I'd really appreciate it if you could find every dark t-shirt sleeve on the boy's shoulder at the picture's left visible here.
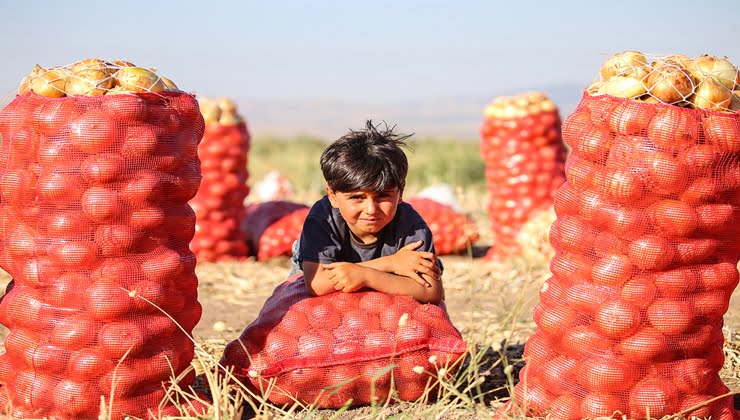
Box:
[298,217,342,264]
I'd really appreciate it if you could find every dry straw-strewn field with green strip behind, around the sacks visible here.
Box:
[2,138,740,419]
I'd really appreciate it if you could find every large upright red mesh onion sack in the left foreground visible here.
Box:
[0,59,204,419]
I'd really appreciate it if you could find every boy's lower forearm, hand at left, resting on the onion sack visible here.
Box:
[321,262,444,304]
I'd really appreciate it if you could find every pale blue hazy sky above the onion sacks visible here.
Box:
[0,0,740,102]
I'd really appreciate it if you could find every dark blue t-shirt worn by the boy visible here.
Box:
[291,196,442,275]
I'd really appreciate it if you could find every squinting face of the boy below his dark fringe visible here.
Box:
[326,187,402,244]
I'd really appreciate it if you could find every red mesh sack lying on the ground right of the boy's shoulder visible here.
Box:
[404,197,479,255]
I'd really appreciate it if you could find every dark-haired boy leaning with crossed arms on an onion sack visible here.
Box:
[291,121,444,304]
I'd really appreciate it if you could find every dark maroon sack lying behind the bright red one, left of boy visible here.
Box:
[241,200,308,253]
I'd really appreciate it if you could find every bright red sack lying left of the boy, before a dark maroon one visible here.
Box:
[247,202,311,261]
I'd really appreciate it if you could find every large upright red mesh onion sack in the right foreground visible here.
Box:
[502,51,740,419]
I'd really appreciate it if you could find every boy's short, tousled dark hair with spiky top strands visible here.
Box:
[321,120,411,192]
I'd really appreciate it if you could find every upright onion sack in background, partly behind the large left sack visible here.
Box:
[190,98,249,262]
